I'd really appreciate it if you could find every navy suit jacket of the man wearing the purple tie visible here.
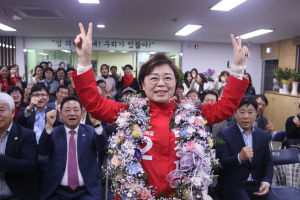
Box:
[38,124,107,200]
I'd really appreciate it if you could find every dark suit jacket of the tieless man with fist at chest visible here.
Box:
[216,124,273,199]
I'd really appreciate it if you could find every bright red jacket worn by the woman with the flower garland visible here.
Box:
[72,69,249,194]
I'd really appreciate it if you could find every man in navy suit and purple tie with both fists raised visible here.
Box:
[38,96,107,200]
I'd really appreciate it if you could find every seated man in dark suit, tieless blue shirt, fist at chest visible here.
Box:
[216,96,277,200]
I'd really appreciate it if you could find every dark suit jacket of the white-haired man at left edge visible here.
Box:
[0,123,39,200]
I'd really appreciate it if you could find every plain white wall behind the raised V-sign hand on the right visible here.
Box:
[182,42,262,94]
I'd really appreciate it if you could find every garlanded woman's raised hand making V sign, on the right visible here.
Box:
[231,33,250,66]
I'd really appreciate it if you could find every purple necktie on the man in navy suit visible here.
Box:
[68,130,79,190]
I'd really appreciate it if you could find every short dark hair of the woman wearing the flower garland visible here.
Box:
[138,54,179,96]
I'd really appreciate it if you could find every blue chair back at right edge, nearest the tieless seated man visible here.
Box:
[270,148,300,165]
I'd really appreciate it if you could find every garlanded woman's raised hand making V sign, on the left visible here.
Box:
[74,23,93,67]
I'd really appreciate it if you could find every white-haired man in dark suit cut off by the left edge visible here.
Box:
[0,93,38,200]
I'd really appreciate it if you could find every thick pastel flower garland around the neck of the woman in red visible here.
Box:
[106,94,218,200]
